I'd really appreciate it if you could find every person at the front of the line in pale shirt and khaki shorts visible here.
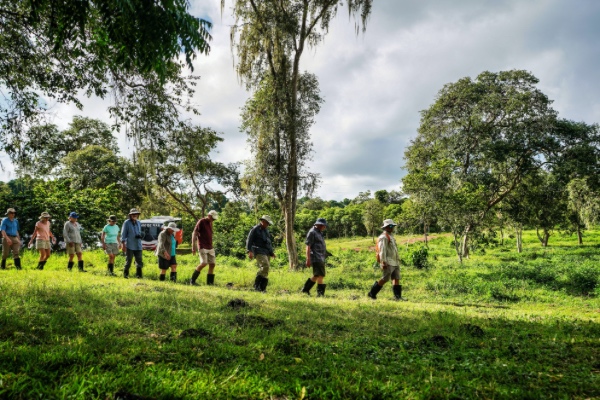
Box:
[367,219,406,301]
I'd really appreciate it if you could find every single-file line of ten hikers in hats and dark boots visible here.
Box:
[0,208,405,300]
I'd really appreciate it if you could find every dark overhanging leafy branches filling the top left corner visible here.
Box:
[0,0,211,157]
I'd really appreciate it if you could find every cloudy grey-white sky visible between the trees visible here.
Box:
[5,0,600,199]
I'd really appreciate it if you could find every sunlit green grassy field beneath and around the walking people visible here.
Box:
[0,232,600,399]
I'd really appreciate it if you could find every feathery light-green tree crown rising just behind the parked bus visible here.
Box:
[143,123,240,220]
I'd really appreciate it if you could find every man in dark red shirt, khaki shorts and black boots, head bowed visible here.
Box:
[190,210,219,286]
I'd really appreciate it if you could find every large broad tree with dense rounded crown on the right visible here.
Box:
[403,70,556,256]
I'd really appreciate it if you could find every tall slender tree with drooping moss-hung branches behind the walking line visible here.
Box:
[226,0,372,269]
